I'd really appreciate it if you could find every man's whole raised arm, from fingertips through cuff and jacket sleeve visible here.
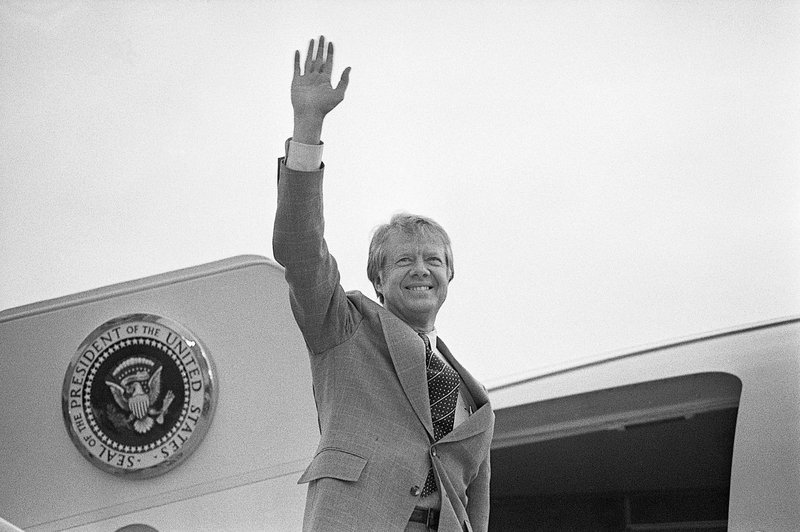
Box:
[272,37,359,354]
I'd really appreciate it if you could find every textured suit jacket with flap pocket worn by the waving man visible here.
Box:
[273,159,494,531]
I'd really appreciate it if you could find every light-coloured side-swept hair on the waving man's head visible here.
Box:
[367,212,455,303]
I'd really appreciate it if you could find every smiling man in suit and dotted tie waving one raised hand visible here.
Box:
[273,37,494,531]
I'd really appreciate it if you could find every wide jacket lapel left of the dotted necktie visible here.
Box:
[378,311,433,438]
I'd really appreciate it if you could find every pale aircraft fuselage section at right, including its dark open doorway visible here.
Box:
[489,318,800,530]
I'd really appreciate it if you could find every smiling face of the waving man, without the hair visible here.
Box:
[375,233,450,332]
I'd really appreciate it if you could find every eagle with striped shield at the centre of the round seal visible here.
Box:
[105,356,175,434]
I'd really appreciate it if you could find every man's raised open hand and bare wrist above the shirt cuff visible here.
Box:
[292,36,350,144]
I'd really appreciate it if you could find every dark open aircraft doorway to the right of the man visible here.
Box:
[490,373,741,532]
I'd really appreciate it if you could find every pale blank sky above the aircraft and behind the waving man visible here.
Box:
[0,0,800,382]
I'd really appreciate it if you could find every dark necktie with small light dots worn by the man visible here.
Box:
[419,333,461,497]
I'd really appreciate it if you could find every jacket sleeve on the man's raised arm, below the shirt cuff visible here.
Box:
[272,158,360,354]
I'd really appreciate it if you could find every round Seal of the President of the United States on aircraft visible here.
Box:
[61,314,217,478]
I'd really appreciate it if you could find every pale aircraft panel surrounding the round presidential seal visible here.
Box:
[0,256,319,531]
